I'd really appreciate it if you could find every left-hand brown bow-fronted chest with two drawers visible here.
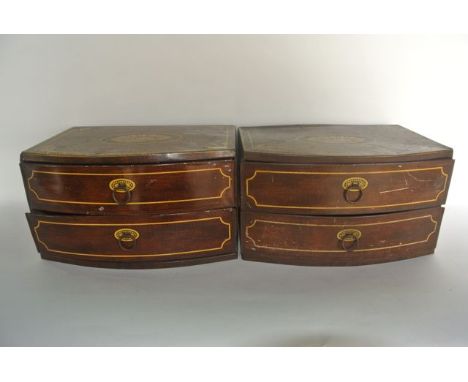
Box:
[20,126,237,268]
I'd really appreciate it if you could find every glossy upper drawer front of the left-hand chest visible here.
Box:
[22,160,235,215]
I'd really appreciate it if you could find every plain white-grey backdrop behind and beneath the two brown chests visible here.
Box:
[0,35,468,345]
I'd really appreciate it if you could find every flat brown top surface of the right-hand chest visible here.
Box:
[240,125,452,163]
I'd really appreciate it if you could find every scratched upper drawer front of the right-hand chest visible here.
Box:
[241,159,453,215]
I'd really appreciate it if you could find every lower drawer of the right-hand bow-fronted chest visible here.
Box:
[241,207,443,265]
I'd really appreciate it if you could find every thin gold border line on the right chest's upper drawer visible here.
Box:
[245,166,448,210]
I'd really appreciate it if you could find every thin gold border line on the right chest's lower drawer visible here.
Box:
[245,215,438,253]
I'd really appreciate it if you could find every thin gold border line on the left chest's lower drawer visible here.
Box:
[33,216,232,258]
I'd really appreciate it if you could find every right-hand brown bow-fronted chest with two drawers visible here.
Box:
[240,125,454,265]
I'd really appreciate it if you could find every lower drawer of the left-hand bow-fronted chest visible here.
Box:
[26,209,237,268]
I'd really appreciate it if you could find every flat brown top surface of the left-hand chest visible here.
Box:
[21,125,235,164]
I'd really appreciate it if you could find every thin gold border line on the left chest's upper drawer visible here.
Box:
[28,167,232,205]
